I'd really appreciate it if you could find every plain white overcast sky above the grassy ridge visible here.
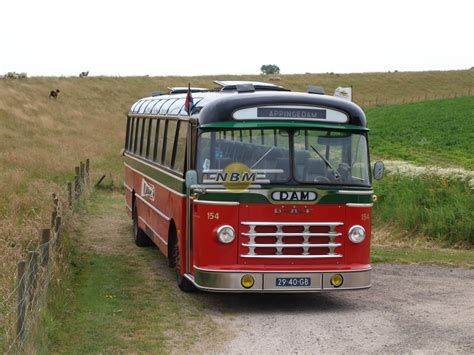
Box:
[0,0,474,76]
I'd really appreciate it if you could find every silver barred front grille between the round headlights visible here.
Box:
[240,222,344,259]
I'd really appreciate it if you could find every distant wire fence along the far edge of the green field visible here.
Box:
[354,88,474,107]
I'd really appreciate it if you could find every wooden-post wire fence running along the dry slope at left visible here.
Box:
[0,159,91,354]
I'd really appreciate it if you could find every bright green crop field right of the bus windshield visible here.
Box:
[366,96,474,170]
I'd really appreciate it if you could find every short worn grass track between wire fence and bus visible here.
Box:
[39,191,219,354]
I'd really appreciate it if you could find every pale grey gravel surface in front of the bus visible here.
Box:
[196,265,474,354]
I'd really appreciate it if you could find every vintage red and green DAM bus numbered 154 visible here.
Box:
[123,81,383,292]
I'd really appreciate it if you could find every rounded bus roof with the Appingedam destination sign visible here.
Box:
[129,83,367,127]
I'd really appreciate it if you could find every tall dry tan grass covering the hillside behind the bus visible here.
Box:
[0,70,474,318]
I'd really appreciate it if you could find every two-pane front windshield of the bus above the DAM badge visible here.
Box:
[197,129,370,186]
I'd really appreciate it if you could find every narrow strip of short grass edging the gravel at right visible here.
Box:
[372,246,474,269]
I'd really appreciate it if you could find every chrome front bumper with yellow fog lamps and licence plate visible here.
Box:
[185,266,372,293]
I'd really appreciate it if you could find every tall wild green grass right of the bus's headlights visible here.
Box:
[373,175,474,247]
